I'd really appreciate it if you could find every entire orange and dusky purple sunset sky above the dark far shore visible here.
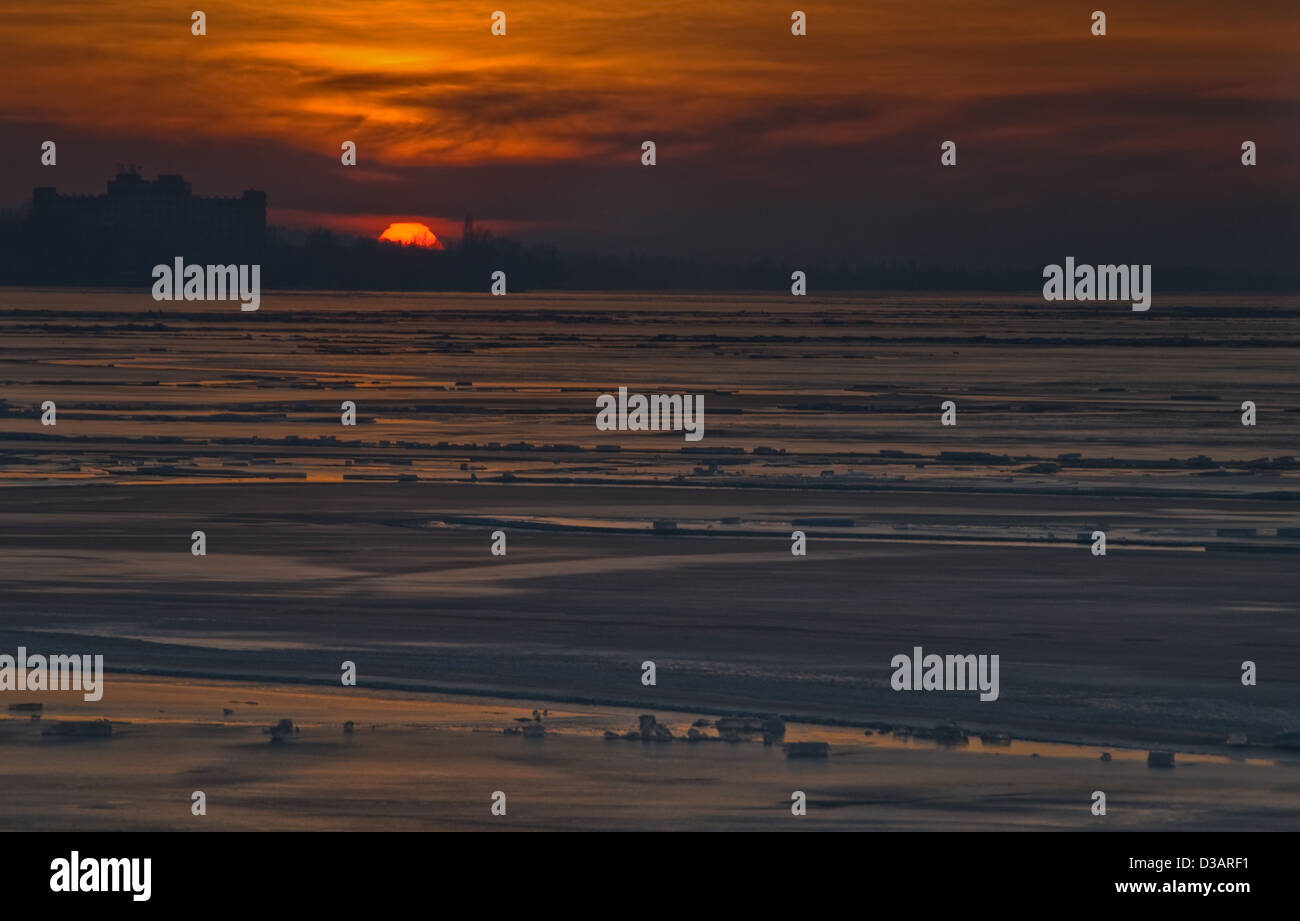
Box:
[0,0,1300,269]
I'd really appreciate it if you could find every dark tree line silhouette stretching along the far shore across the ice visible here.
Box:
[0,213,1300,294]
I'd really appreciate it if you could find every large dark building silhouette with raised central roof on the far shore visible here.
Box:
[27,168,267,284]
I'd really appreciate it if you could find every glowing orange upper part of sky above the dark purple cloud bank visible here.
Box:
[0,0,1300,163]
